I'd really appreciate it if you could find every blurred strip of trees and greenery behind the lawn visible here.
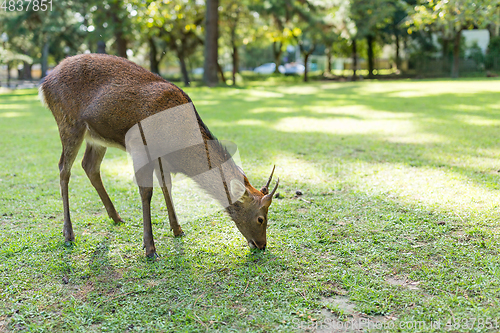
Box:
[0,0,500,88]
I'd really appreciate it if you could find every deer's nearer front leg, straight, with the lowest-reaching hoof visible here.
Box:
[136,163,158,258]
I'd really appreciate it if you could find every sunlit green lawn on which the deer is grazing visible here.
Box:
[0,78,500,332]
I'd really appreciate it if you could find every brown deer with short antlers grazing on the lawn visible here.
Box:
[39,54,279,258]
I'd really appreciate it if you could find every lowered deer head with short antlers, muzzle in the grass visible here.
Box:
[226,167,279,250]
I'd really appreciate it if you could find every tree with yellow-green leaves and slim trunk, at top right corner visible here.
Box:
[408,0,500,78]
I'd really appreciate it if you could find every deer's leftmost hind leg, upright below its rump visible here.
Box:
[59,125,85,242]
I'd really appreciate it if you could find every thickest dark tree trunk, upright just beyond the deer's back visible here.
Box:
[203,0,219,87]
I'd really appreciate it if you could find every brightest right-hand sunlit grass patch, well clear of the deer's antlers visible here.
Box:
[350,162,500,222]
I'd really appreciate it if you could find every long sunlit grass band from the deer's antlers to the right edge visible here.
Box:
[260,150,500,222]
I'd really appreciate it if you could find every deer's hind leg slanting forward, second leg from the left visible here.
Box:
[82,142,123,224]
